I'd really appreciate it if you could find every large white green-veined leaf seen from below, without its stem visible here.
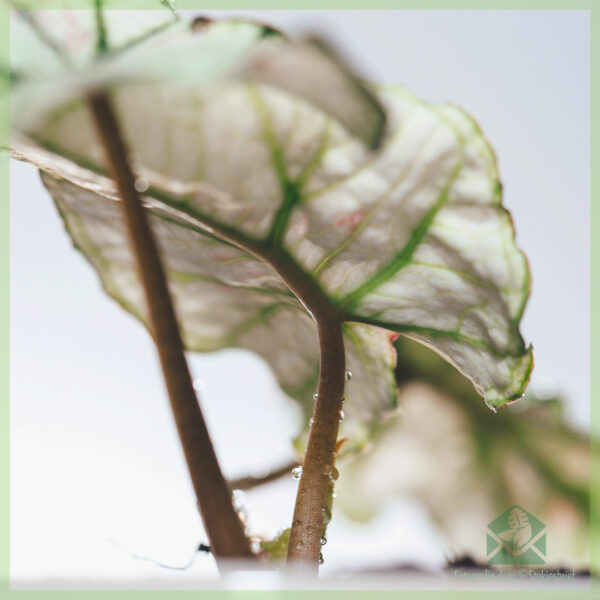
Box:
[13,12,532,436]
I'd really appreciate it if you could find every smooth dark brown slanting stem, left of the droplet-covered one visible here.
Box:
[89,93,254,559]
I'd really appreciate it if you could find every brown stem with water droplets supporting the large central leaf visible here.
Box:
[288,312,346,571]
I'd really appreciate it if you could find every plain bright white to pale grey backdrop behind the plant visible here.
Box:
[11,11,590,586]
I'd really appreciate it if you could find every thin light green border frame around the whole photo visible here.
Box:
[0,0,600,600]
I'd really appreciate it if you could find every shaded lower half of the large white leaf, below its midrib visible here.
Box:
[36,173,396,442]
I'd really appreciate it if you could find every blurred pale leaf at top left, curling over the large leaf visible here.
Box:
[11,7,385,147]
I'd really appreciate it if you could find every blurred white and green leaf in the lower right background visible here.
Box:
[337,338,600,572]
